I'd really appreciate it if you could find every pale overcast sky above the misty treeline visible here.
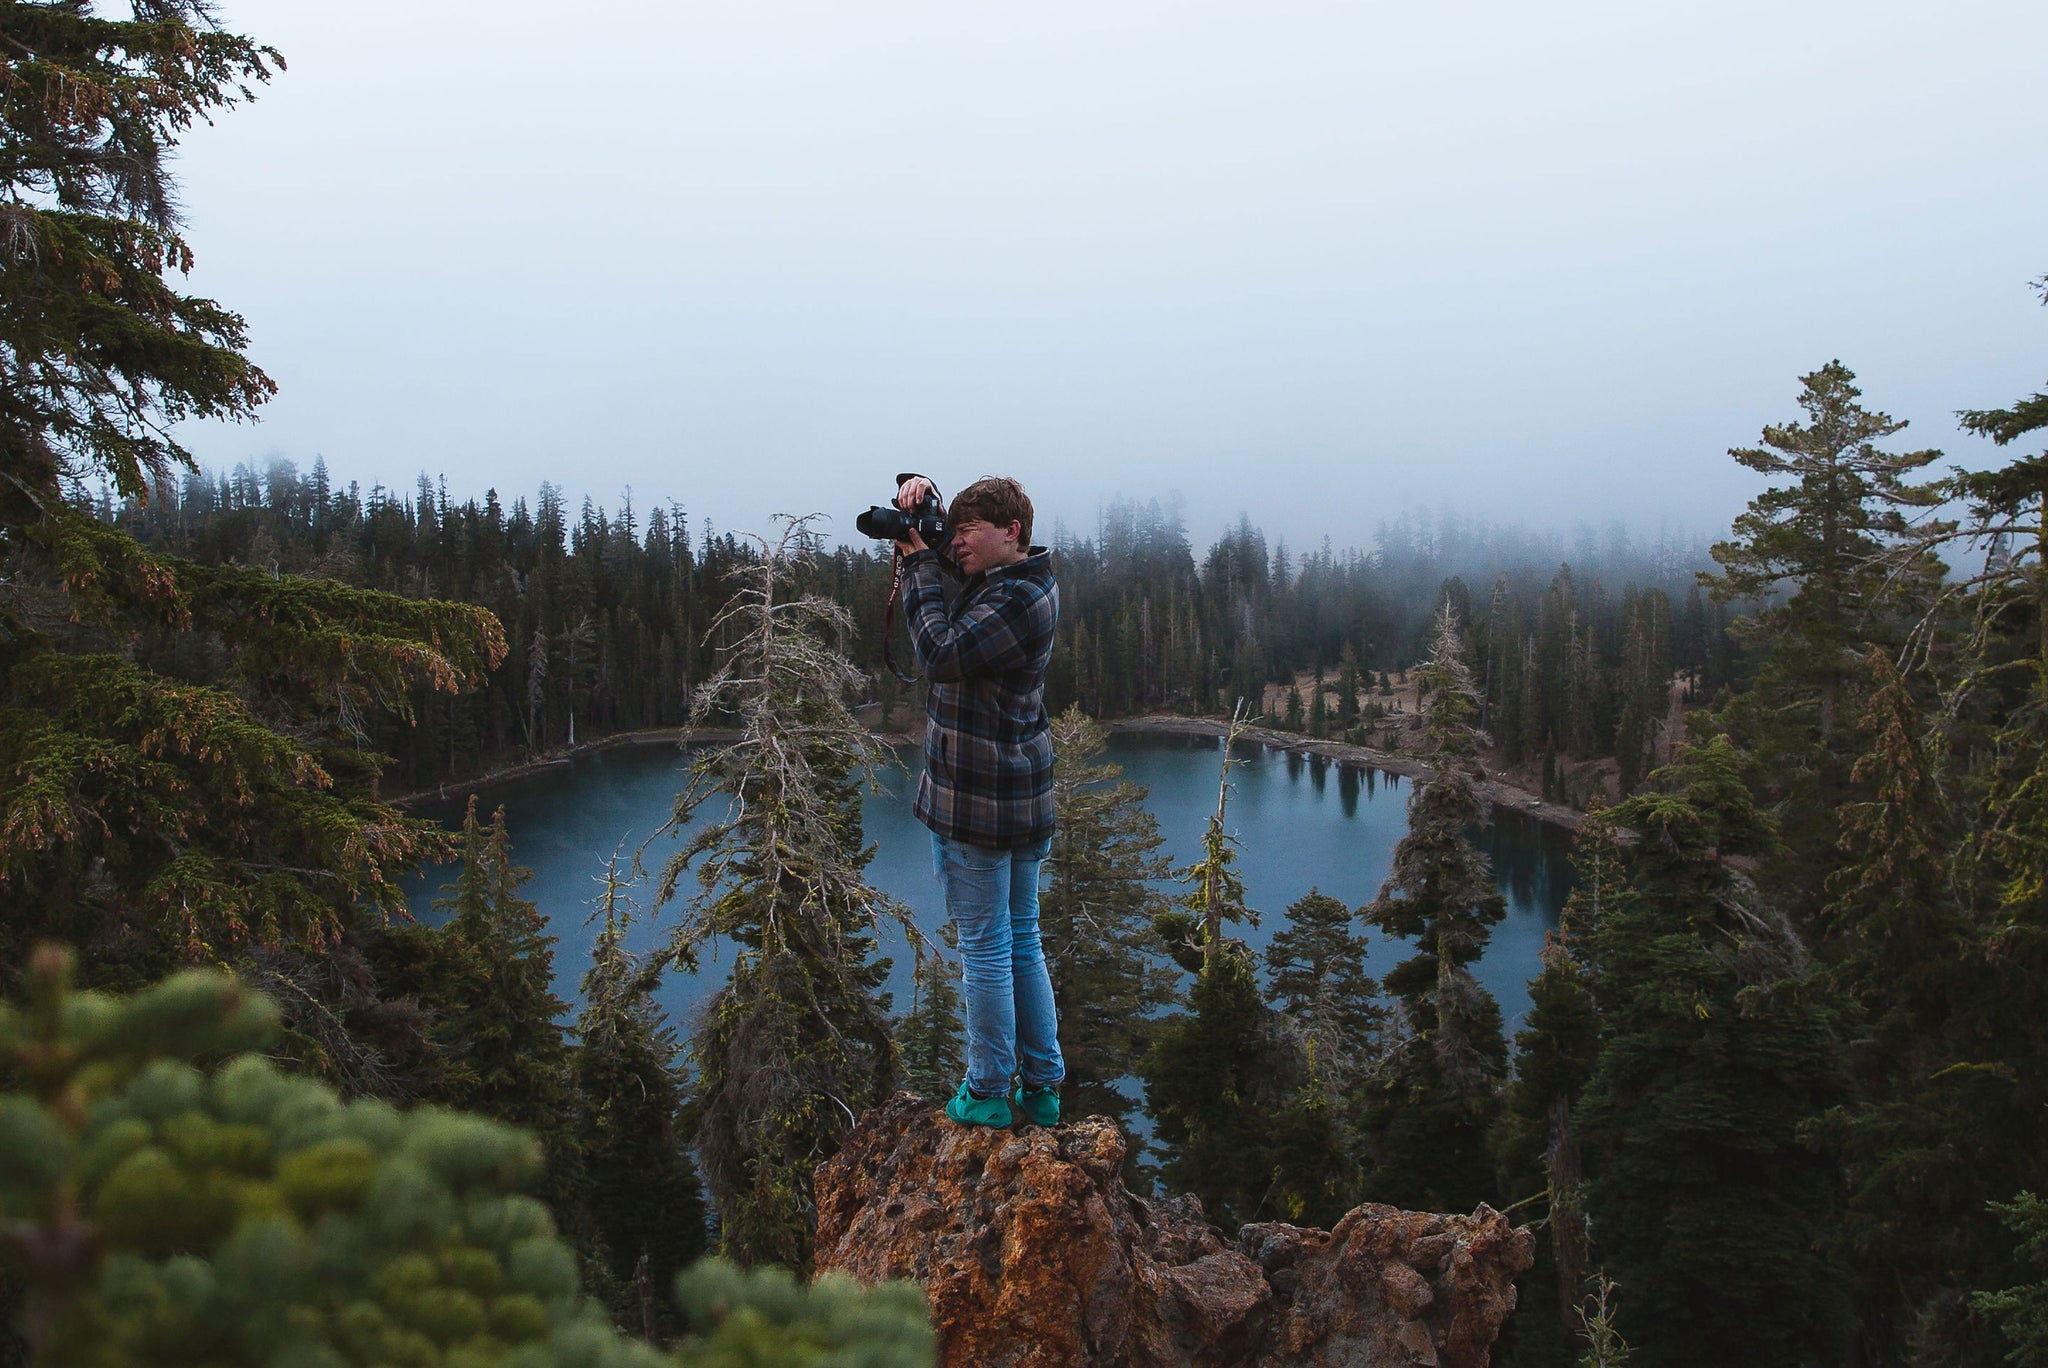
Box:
[180,0,2048,547]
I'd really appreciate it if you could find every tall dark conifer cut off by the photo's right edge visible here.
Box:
[1819,286,2048,1362]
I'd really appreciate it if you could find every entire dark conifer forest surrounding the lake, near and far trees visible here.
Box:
[0,0,2048,1368]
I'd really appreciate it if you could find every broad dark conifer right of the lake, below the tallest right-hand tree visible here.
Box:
[1573,737,1845,1368]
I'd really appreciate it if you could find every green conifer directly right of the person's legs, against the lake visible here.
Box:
[1038,707,1174,1138]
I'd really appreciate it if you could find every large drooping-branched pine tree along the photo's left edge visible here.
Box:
[0,0,504,995]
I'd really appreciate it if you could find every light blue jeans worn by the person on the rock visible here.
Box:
[932,831,1067,1098]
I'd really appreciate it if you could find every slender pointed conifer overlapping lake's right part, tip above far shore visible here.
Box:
[1360,606,1507,1210]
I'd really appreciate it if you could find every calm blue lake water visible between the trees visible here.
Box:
[408,735,1571,1036]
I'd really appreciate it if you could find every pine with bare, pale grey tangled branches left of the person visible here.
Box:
[657,518,924,1272]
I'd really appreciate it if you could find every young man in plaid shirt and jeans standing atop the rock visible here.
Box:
[897,475,1067,1126]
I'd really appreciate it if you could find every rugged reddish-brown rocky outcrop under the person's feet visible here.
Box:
[815,1096,1534,1368]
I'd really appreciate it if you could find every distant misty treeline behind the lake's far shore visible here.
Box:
[100,459,1731,786]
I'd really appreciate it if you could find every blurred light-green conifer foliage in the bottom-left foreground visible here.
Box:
[0,948,930,1368]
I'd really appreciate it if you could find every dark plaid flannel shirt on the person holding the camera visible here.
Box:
[903,547,1059,850]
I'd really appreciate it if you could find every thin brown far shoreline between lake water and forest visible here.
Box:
[387,713,1581,831]
